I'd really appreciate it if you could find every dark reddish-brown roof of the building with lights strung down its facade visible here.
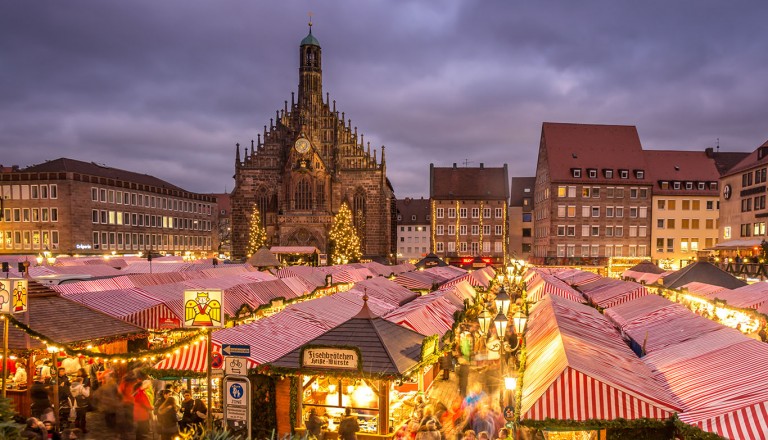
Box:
[429,164,509,200]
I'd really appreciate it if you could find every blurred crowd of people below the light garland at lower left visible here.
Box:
[22,360,208,440]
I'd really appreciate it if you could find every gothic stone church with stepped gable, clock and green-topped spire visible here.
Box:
[232,25,396,259]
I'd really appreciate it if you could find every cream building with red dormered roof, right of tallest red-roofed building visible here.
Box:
[645,149,720,270]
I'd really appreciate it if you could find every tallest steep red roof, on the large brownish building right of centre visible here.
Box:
[541,122,651,184]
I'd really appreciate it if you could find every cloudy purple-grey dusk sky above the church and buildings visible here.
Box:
[0,0,768,197]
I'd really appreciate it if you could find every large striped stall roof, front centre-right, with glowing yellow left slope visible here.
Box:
[521,295,681,421]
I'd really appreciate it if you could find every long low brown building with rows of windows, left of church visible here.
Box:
[0,158,218,255]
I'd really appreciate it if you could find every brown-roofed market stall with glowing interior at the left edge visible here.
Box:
[0,281,147,417]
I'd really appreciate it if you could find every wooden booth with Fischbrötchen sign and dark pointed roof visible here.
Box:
[262,297,439,440]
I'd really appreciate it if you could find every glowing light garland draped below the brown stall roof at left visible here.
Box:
[8,315,205,364]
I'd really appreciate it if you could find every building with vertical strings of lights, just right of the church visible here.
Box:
[429,163,510,265]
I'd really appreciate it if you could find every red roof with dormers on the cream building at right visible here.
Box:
[645,150,720,195]
